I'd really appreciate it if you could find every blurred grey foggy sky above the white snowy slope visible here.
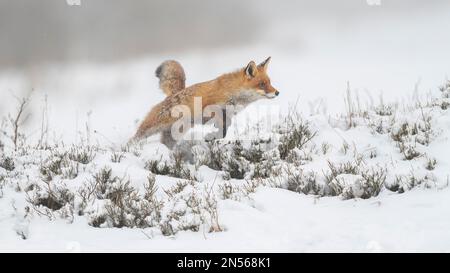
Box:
[0,0,450,68]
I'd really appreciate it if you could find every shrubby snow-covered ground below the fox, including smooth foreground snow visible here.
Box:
[0,78,450,251]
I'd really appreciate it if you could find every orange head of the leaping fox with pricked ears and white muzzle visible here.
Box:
[244,57,280,99]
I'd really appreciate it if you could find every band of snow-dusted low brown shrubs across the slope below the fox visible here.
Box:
[0,79,450,242]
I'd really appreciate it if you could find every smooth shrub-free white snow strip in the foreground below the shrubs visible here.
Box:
[0,186,450,252]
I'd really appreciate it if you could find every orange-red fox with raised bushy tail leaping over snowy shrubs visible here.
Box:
[133,57,279,149]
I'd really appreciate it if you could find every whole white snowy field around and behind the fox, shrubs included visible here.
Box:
[0,3,450,252]
